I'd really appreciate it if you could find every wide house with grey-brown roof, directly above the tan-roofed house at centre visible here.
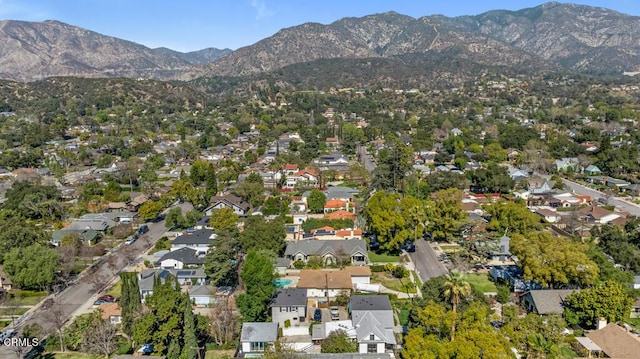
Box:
[284,239,369,265]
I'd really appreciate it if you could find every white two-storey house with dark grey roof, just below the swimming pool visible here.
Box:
[271,288,307,328]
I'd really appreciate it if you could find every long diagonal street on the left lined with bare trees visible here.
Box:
[0,203,193,358]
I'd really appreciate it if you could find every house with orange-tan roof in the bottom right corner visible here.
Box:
[576,319,640,359]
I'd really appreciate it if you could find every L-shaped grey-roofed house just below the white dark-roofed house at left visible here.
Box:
[138,268,207,302]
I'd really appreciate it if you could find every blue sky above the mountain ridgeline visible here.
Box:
[0,0,640,51]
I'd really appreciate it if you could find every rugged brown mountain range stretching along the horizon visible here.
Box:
[0,2,640,83]
